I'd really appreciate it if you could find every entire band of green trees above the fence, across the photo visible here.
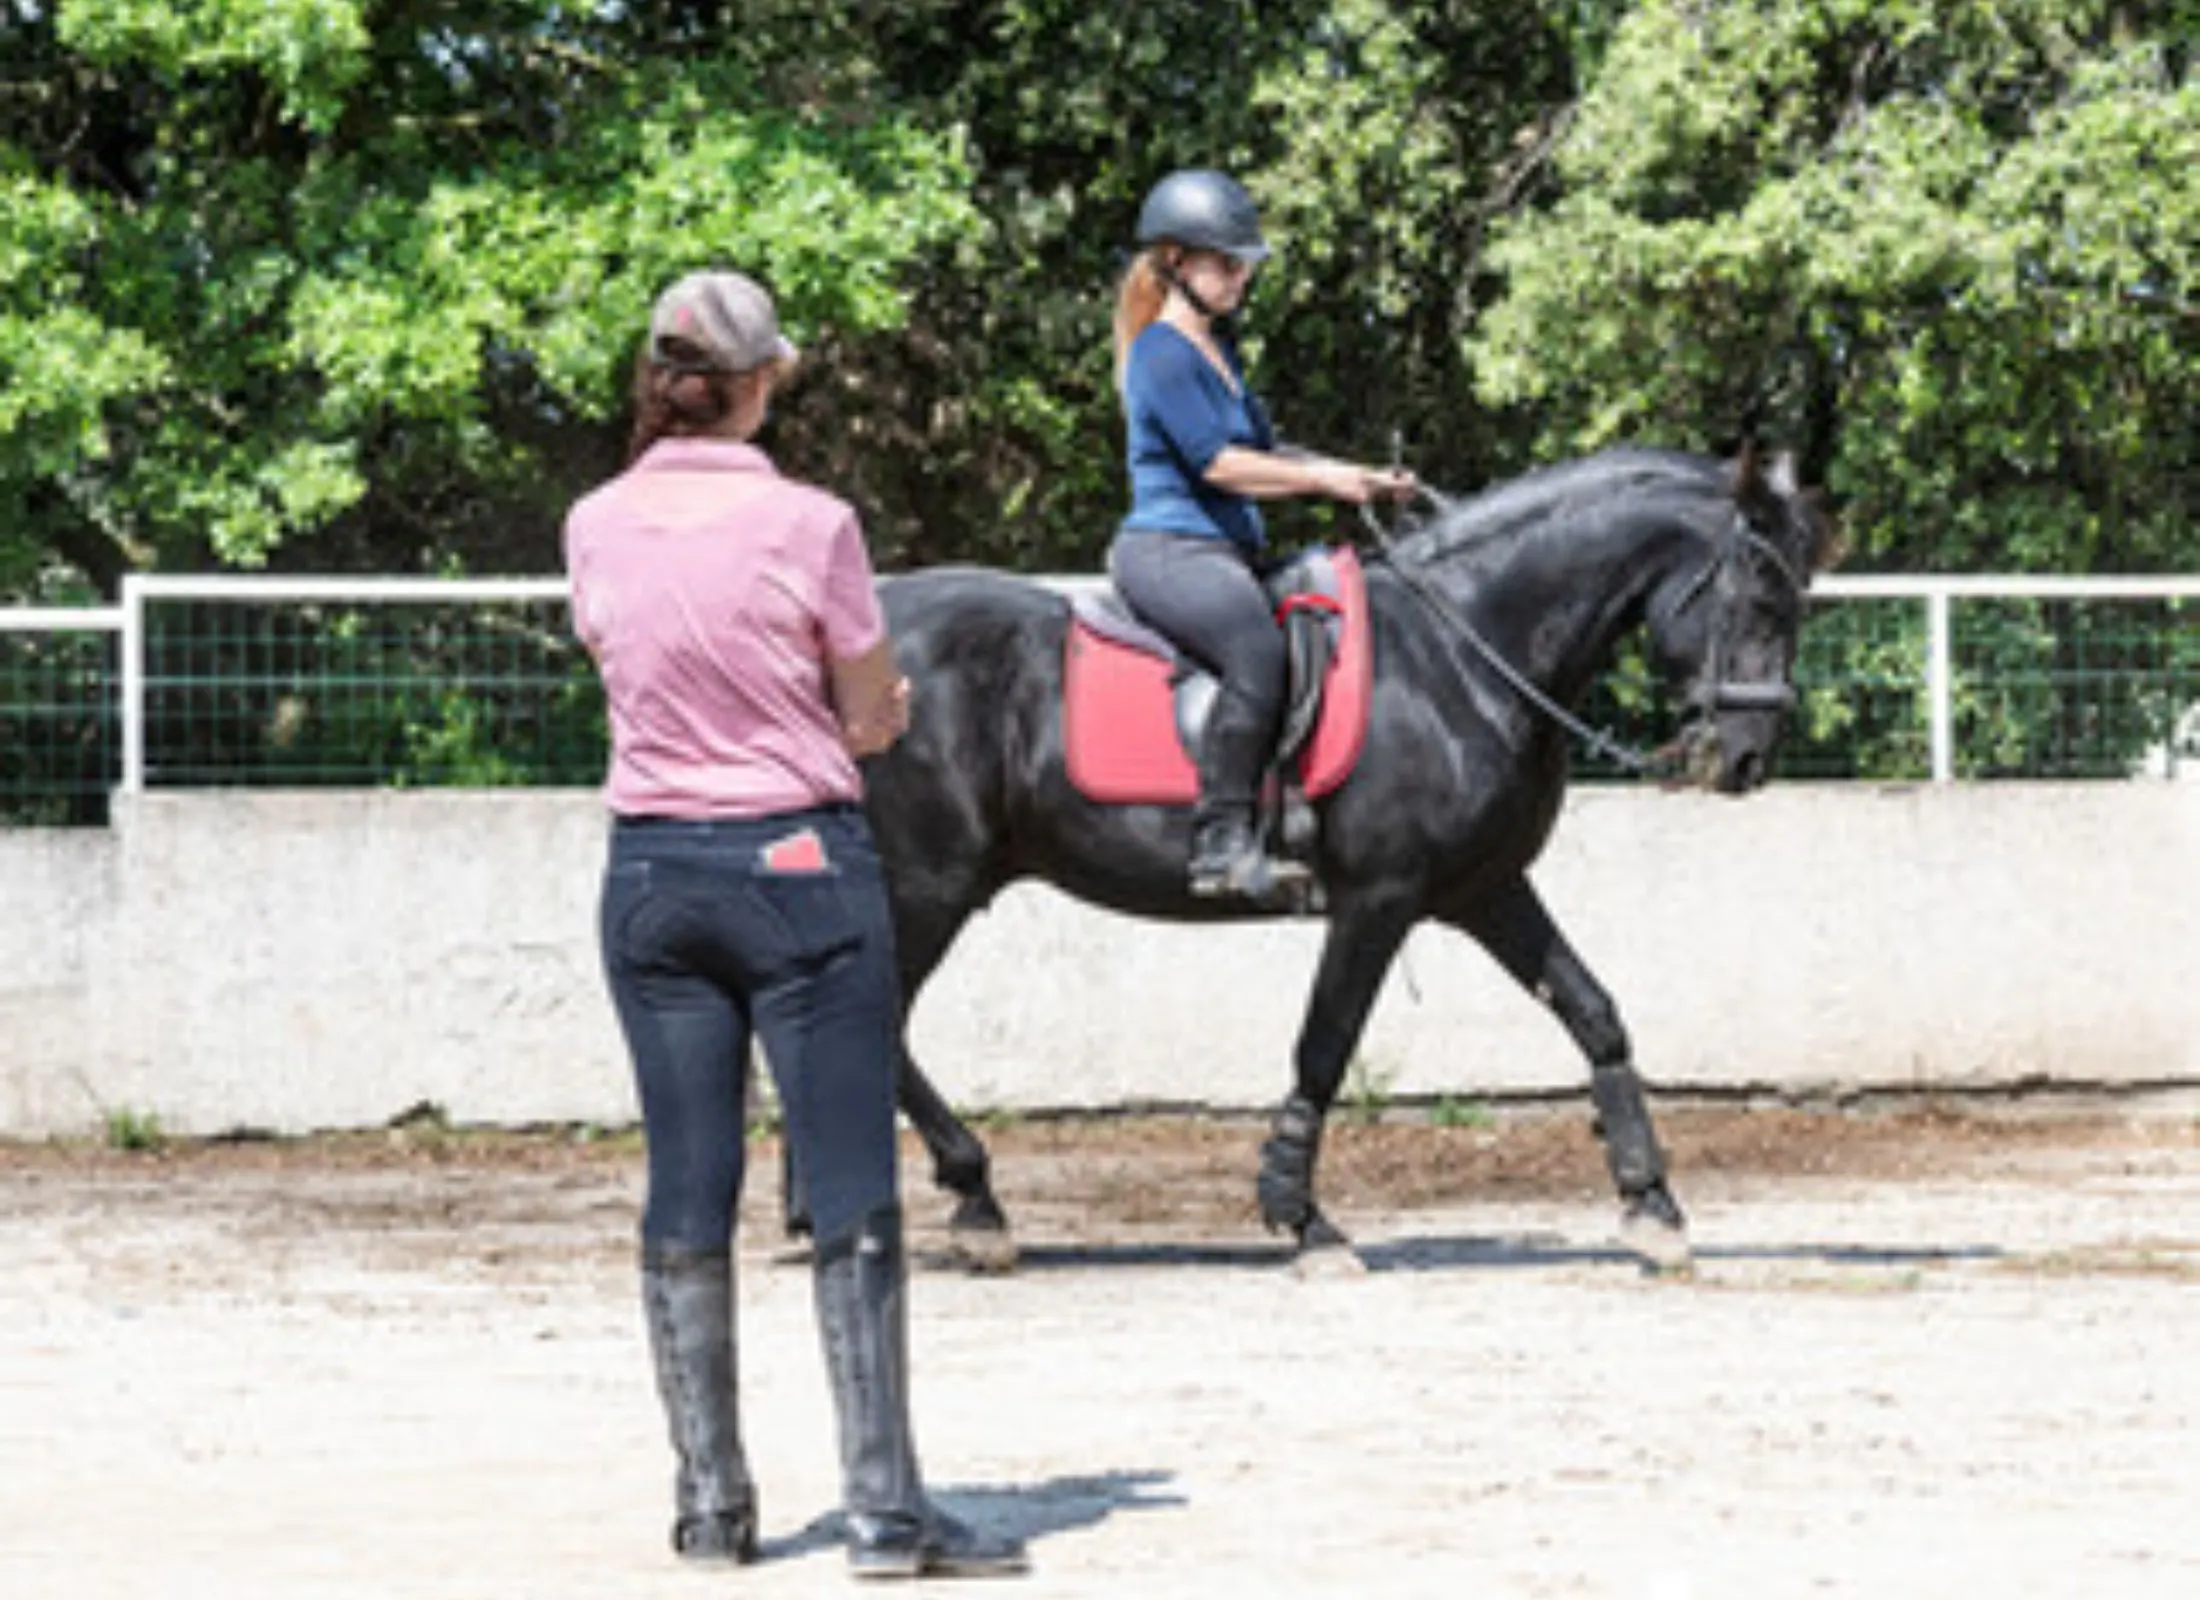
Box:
[0,0,2200,594]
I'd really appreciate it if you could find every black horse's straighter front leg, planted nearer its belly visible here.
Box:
[1258,898,1419,1250]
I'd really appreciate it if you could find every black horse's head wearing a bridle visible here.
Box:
[1646,447,1835,794]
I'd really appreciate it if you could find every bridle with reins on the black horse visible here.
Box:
[1360,495,1806,777]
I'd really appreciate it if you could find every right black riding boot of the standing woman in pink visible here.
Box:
[814,1206,1027,1578]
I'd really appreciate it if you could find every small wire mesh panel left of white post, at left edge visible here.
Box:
[0,612,121,828]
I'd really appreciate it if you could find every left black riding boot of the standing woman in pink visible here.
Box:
[642,1246,757,1563]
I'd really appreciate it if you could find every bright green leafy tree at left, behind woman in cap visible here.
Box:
[0,0,975,592]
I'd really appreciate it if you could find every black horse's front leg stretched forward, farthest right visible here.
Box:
[1443,878,1690,1270]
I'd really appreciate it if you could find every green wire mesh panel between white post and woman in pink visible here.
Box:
[143,594,605,788]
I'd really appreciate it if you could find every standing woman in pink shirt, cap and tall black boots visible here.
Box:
[565,273,1023,1578]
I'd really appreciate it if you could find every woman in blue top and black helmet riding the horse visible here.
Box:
[1109,169,1415,900]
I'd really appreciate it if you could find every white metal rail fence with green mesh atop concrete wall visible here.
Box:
[0,574,2200,814]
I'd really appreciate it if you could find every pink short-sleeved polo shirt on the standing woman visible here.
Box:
[565,438,887,817]
